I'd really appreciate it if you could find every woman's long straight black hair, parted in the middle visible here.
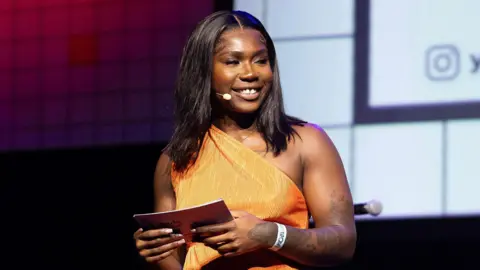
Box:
[165,11,305,172]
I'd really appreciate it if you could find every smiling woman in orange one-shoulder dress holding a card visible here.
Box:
[135,11,356,269]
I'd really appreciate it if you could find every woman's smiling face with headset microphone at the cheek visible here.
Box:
[212,28,273,113]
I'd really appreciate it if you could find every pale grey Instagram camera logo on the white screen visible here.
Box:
[425,45,460,81]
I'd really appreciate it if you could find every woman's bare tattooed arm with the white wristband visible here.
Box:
[249,126,356,266]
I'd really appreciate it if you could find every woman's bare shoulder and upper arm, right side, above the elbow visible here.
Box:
[290,124,354,231]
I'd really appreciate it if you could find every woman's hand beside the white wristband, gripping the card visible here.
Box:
[192,211,277,257]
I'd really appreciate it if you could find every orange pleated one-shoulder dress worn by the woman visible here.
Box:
[172,126,308,270]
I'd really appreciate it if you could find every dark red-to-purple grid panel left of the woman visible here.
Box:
[0,0,213,151]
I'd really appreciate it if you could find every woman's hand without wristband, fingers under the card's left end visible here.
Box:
[134,229,185,263]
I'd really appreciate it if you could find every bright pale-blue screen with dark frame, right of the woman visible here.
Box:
[234,0,480,218]
